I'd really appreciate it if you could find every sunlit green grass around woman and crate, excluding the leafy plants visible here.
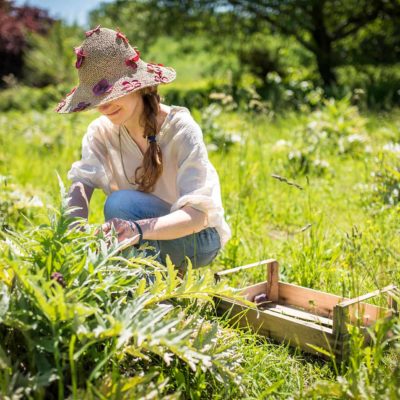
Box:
[0,97,400,399]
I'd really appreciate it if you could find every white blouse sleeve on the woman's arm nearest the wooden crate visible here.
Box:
[171,117,223,226]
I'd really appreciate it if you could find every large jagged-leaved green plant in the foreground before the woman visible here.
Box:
[0,183,245,399]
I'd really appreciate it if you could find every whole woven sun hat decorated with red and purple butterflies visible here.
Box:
[55,25,176,114]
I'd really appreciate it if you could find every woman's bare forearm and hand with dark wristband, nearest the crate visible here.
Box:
[102,206,207,244]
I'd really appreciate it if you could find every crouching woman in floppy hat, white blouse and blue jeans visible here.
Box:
[56,26,230,269]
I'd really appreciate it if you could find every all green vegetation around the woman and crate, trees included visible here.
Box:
[0,0,400,399]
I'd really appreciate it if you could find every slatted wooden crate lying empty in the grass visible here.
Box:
[215,259,398,359]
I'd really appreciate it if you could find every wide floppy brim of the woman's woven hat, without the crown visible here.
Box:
[55,60,176,114]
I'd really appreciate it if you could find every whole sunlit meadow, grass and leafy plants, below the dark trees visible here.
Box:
[0,89,400,399]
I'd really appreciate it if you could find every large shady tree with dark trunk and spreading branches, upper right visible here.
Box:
[152,0,400,87]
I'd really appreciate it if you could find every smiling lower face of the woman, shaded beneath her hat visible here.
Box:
[97,92,143,125]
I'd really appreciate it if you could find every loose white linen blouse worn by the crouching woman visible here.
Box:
[68,105,231,246]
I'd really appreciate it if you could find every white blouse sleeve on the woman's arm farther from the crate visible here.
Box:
[67,121,109,193]
